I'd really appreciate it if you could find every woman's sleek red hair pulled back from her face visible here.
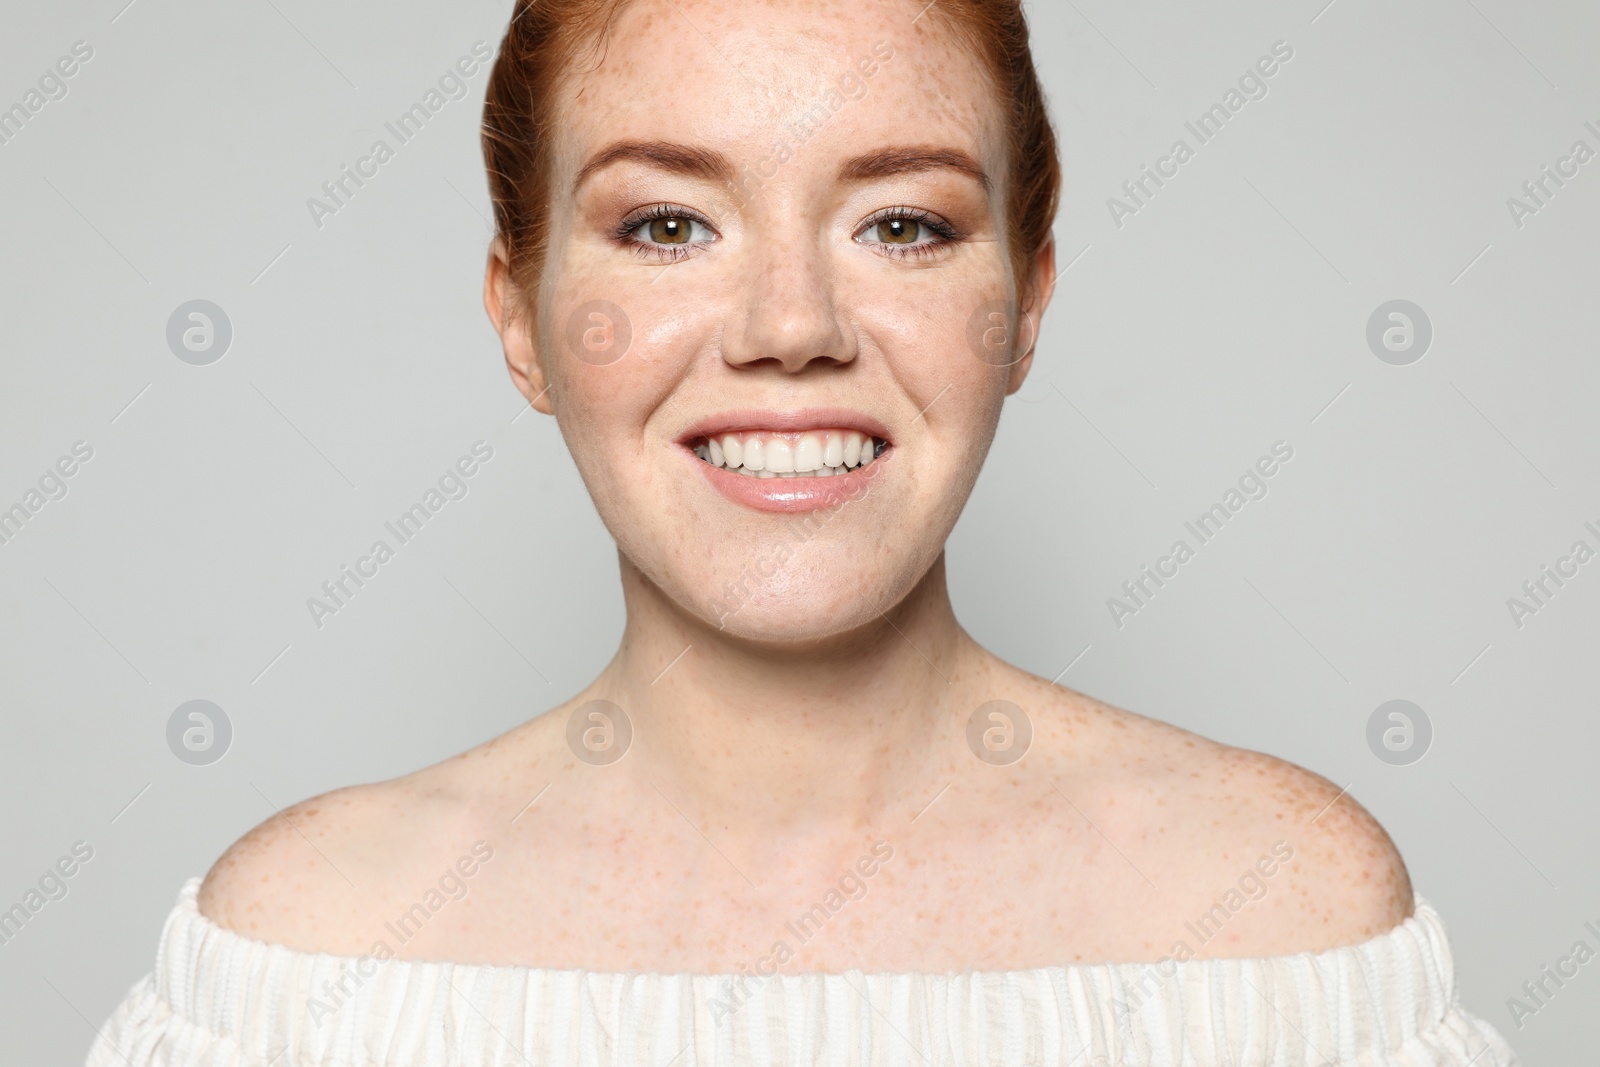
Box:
[483,0,1061,326]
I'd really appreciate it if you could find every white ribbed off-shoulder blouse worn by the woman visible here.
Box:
[88,878,1518,1067]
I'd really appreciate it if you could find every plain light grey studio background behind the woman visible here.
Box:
[0,0,1600,1064]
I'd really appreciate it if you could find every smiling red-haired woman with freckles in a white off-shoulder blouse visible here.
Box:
[90,0,1515,1067]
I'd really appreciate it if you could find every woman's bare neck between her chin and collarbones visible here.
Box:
[592,553,986,840]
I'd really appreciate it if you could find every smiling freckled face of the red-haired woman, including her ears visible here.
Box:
[491,0,1050,643]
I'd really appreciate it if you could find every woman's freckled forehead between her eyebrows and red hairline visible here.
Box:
[557,0,1002,179]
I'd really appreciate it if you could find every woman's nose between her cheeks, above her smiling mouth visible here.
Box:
[723,227,856,374]
